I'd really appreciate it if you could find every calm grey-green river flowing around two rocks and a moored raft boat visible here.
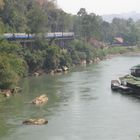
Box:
[0,55,140,140]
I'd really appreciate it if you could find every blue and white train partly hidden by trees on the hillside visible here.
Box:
[1,32,74,40]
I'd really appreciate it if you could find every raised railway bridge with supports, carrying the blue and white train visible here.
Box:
[1,32,75,47]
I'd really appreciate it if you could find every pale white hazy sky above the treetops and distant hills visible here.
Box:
[57,0,140,15]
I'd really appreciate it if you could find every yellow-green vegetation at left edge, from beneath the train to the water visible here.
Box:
[0,42,27,89]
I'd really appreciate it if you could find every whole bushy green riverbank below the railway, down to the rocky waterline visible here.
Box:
[0,40,140,93]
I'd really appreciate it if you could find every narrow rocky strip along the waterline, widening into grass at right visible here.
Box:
[31,46,140,76]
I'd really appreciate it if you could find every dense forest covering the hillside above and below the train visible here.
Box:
[0,0,140,89]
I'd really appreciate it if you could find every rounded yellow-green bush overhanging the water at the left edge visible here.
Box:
[0,54,25,89]
